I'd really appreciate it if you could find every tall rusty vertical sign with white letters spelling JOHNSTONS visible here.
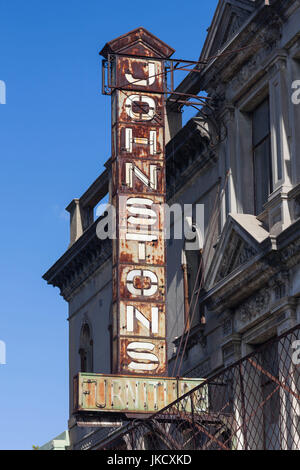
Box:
[101,28,174,375]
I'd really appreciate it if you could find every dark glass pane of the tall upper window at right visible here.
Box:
[254,138,272,214]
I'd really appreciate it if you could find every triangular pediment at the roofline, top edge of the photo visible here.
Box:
[200,0,255,60]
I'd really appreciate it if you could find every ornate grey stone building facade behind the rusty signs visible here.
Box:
[44,0,300,449]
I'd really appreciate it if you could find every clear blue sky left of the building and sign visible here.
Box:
[0,0,217,449]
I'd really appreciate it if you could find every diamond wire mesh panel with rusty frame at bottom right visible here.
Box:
[98,326,300,450]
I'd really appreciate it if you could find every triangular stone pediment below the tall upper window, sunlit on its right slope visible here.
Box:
[205,214,269,288]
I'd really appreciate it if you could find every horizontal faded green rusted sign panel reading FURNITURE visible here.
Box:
[74,373,208,414]
